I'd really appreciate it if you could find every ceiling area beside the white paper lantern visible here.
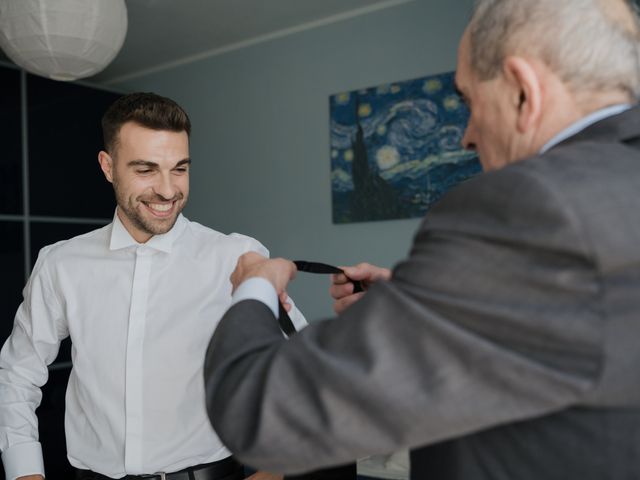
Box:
[2,0,413,84]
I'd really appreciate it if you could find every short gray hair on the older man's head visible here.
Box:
[468,0,640,98]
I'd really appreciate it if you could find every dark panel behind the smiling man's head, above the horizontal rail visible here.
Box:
[27,75,120,218]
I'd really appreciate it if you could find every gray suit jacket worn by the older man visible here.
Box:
[205,108,640,480]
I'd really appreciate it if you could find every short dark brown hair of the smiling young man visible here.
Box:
[102,92,191,155]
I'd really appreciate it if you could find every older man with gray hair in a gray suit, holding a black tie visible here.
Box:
[205,0,640,480]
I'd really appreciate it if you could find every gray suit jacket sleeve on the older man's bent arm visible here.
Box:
[205,166,603,473]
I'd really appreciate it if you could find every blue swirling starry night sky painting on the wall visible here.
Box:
[329,72,480,223]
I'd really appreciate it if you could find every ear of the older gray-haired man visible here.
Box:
[503,56,542,133]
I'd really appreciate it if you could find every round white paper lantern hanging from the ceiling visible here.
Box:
[0,0,127,80]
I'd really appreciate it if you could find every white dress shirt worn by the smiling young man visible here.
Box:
[0,215,306,479]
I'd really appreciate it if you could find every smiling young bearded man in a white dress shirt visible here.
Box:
[0,93,304,480]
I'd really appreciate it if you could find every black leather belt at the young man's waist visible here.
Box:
[76,457,244,480]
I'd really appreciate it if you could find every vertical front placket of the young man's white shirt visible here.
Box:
[124,245,153,473]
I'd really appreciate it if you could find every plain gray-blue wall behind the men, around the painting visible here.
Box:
[114,0,472,319]
